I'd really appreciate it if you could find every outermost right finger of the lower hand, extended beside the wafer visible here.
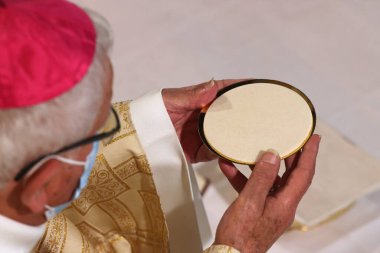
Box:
[278,135,320,206]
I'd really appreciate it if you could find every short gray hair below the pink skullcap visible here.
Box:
[0,9,112,188]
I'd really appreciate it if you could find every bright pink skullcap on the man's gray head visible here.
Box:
[0,0,96,109]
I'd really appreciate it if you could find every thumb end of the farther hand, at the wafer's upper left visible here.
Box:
[188,79,218,110]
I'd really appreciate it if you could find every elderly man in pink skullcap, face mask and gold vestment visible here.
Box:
[0,0,320,252]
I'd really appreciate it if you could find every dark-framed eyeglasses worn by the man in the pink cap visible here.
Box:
[14,107,120,181]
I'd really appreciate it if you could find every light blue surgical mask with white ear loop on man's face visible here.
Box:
[45,141,99,220]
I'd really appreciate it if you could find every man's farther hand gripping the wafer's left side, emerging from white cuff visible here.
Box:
[162,79,242,163]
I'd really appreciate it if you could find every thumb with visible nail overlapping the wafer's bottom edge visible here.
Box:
[241,152,280,210]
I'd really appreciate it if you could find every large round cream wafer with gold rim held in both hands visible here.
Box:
[199,79,316,164]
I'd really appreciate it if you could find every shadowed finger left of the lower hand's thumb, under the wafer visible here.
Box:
[219,159,247,193]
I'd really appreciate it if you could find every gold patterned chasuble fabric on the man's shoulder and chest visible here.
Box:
[33,102,237,253]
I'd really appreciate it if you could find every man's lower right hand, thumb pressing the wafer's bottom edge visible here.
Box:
[215,135,320,253]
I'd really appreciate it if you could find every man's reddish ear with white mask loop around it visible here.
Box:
[21,160,62,213]
